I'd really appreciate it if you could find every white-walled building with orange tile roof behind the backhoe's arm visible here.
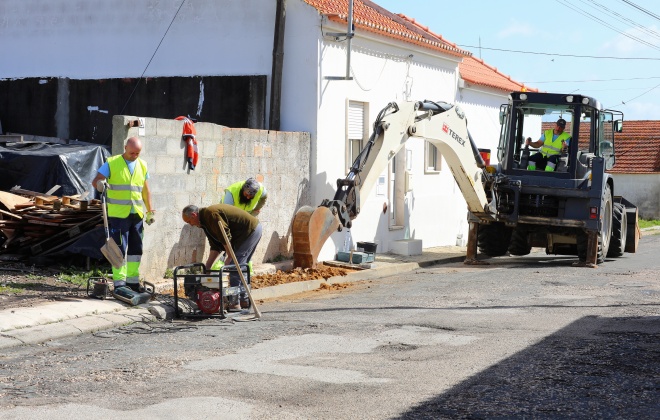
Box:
[0,0,525,260]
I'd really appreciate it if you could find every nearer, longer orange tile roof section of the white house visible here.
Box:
[303,0,471,57]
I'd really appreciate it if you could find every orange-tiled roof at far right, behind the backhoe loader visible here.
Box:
[542,120,660,174]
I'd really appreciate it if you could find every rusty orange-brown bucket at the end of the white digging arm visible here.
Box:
[293,206,339,268]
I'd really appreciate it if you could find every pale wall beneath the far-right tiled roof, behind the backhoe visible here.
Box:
[612,174,660,219]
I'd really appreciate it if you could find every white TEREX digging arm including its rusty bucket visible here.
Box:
[293,101,491,268]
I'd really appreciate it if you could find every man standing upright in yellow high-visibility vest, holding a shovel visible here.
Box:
[92,137,156,292]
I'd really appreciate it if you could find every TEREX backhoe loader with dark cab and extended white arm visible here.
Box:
[293,92,640,267]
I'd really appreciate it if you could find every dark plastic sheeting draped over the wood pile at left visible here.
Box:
[0,141,110,197]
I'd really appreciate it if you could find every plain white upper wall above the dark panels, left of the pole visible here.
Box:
[0,0,276,79]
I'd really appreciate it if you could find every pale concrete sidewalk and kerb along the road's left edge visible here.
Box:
[0,246,466,349]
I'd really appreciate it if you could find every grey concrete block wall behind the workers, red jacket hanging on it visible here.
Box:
[112,115,311,281]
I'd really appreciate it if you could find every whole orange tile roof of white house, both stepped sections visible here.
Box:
[303,0,538,92]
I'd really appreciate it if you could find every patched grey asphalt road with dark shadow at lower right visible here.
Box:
[0,235,660,420]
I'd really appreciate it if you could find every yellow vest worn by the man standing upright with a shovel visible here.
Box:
[108,155,147,219]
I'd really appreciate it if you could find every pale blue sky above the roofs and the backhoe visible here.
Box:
[372,0,660,120]
